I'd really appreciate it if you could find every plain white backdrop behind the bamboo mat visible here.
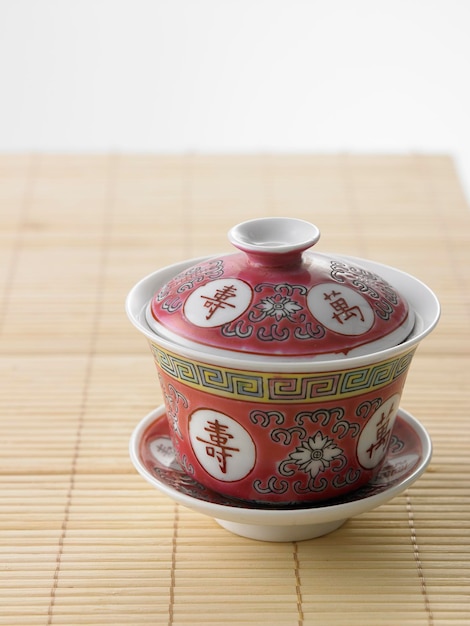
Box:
[0,0,470,197]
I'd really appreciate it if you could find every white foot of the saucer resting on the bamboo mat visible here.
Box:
[214,518,347,542]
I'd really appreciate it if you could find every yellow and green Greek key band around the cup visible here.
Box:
[150,343,415,403]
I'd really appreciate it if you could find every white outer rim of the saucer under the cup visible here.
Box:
[129,405,432,526]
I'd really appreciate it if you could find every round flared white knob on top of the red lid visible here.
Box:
[228,217,320,267]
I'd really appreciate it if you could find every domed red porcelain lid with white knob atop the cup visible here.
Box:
[147,218,414,358]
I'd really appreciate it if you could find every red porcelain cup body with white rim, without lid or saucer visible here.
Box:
[127,254,439,506]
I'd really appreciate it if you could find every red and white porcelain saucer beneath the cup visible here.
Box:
[129,406,432,541]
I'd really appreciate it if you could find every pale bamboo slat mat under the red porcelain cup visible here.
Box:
[0,154,470,626]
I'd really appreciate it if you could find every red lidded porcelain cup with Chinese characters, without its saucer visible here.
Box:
[127,218,439,507]
